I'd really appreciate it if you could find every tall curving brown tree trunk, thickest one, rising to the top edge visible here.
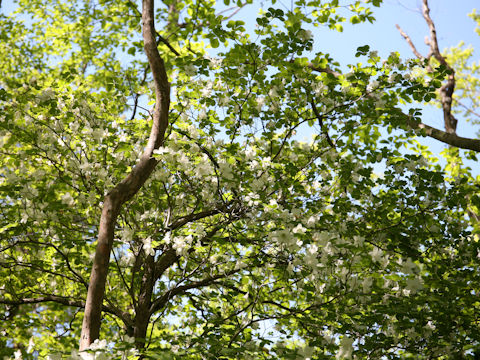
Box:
[80,0,170,350]
